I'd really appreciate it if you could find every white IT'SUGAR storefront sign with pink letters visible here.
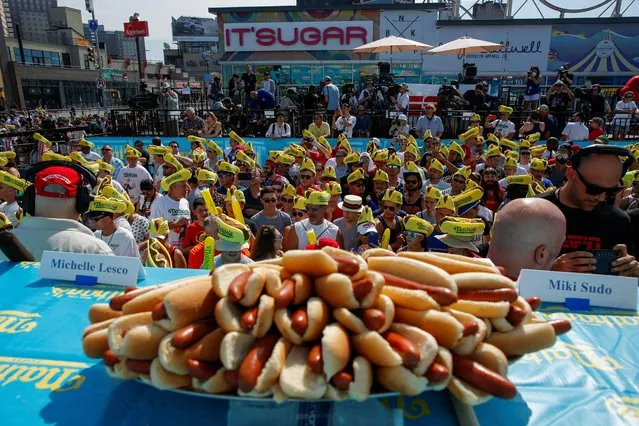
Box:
[224,21,373,52]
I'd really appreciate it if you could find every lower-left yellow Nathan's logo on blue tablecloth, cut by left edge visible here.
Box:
[0,356,90,392]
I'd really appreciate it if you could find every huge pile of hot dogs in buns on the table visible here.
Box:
[83,247,570,405]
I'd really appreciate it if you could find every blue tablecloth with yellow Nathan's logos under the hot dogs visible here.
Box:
[0,263,639,426]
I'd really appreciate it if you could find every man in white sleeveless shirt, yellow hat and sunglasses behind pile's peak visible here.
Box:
[282,191,344,251]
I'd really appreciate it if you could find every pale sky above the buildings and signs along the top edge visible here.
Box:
[58,0,639,60]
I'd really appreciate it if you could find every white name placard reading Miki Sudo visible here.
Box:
[518,269,637,310]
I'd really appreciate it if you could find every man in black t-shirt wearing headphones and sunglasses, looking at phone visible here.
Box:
[540,153,639,277]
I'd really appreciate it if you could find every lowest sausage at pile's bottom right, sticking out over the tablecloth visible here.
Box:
[453,353,517,399]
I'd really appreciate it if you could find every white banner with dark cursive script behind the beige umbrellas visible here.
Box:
[423,25,551,75]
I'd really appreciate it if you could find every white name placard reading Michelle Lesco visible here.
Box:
[40,251,144,286]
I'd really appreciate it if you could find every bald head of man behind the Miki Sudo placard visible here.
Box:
[488,198,566,280]
